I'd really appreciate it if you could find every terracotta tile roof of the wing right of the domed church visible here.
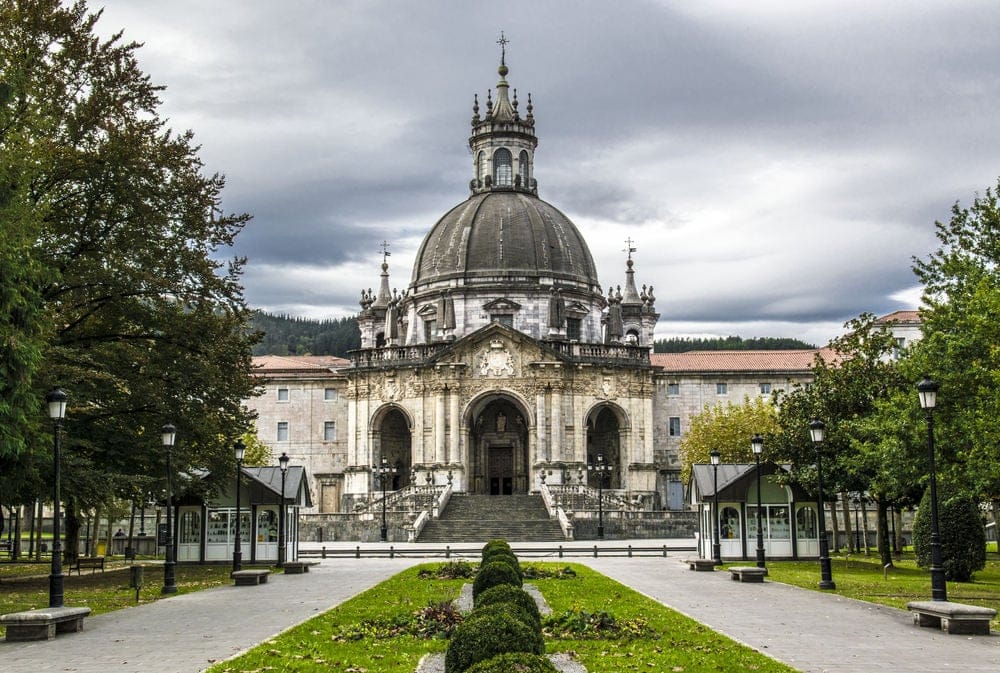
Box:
[649,348,836,372]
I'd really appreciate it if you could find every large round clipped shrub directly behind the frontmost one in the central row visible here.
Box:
[444,610,542,673]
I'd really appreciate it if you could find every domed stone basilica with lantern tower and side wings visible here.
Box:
[247,50,884,540]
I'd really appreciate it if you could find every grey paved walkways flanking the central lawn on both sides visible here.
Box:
[0,541,1000,673]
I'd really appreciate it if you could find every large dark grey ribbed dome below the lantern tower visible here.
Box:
[411,191,599,292]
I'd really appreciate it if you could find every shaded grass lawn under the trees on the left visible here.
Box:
[0,561,248,633]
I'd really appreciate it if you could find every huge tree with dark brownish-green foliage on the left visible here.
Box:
[0,0,258,549]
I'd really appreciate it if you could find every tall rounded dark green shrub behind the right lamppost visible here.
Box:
[913,487,986,582]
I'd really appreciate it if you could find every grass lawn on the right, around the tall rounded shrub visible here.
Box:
[767,552,1000,629]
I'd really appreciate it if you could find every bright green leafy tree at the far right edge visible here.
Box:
[913,177,1000,523]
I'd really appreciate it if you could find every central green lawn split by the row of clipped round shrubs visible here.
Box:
[209,563,795,673]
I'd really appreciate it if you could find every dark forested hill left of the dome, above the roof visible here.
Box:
[252,311,361,357]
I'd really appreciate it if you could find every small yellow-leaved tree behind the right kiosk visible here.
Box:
[680,397,781,483]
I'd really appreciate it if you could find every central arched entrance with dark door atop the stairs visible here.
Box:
[469,396,530,495]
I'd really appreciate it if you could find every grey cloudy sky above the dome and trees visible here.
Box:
[91,0,1000,344]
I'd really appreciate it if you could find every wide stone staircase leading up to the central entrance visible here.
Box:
[417,494,564,543]
